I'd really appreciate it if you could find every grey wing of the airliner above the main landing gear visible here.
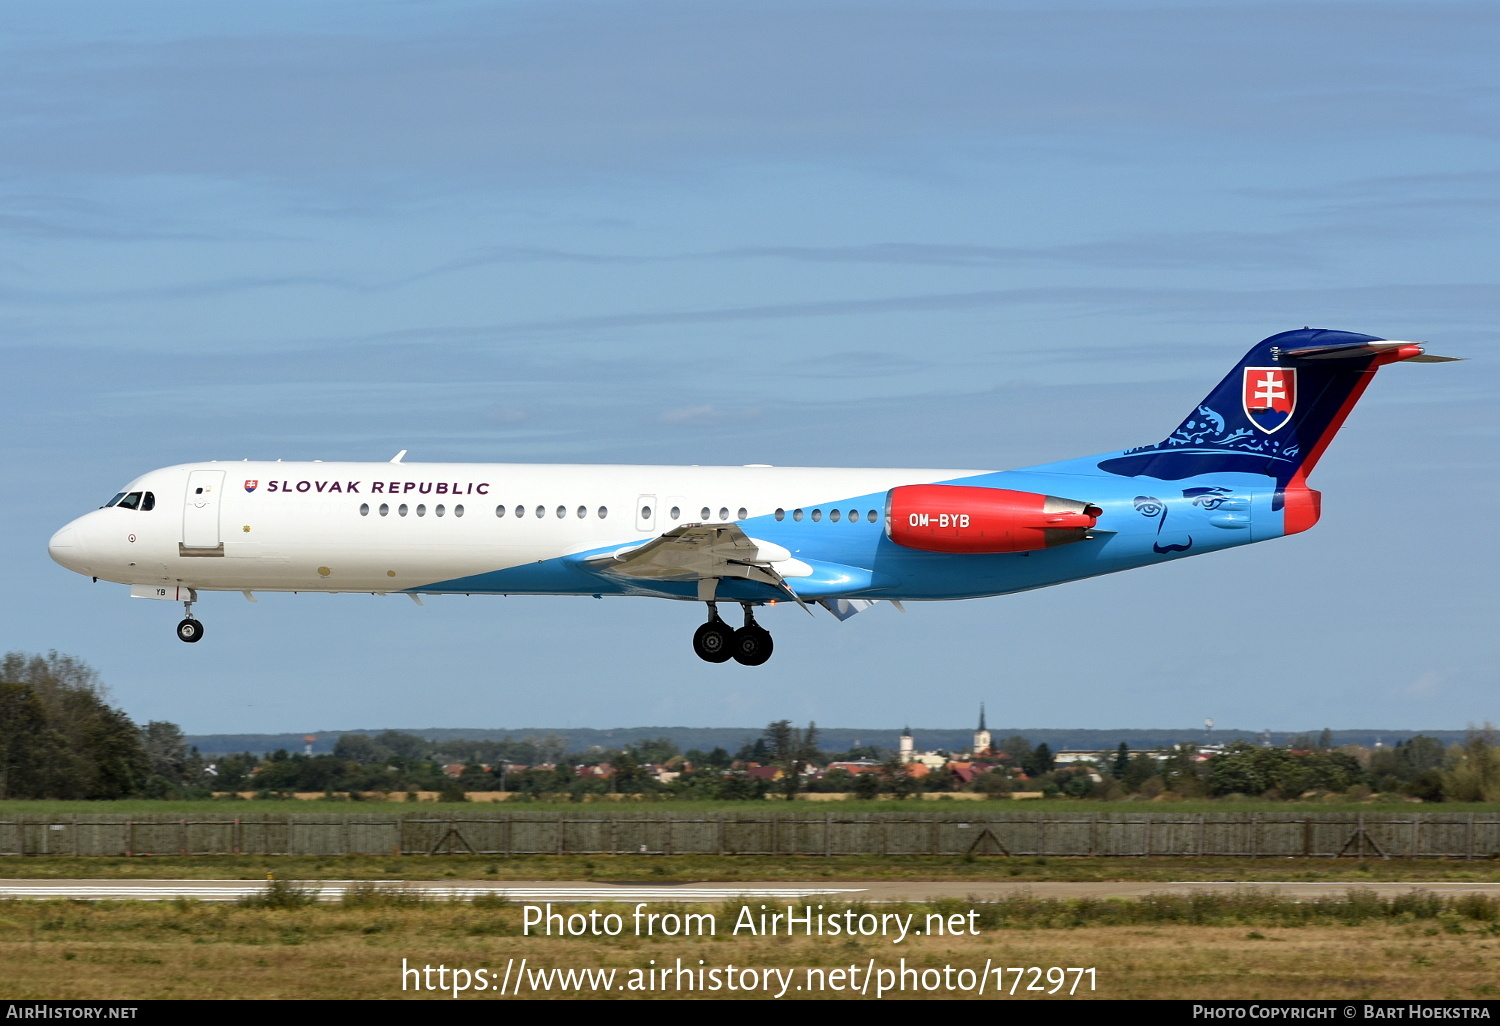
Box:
[585,524,807,608]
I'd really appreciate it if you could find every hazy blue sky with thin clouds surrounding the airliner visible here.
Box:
[0,0,1500,732]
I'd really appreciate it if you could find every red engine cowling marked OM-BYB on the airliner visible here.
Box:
[885,485,1104,554]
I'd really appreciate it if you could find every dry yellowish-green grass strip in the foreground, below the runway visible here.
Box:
[0,891,1500,1001]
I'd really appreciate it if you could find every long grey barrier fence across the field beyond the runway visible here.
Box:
[0,810,1500,858]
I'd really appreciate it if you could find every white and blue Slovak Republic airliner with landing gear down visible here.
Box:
[48,329,1446,666]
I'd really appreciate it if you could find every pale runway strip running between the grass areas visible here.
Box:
[0,881,1500,903]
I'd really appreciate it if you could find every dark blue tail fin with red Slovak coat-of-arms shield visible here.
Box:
[1100,329,1431,491]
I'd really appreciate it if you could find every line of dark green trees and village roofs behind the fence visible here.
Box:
[0,653,1500,801]
